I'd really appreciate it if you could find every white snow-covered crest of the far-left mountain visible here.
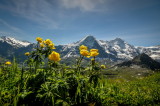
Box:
[0,36,31,48]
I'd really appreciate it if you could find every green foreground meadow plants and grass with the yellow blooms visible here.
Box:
[0,38,160,106]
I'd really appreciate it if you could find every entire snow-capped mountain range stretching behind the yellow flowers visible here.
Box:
[0,35,160,61]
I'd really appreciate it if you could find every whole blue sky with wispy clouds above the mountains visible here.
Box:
[0,0,160,46]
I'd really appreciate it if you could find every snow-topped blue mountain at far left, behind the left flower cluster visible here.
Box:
[0,36,34,61]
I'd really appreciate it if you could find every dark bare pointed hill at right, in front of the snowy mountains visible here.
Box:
[117,53,160,70]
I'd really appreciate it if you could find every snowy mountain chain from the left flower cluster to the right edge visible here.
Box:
[55,35,160,61]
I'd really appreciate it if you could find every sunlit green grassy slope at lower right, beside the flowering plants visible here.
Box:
[105,73,160,106]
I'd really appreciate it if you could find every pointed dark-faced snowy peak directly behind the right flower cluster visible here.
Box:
[58,35,115,59]
